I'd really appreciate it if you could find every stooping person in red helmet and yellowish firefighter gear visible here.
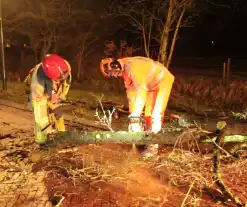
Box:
[24,54,71,146]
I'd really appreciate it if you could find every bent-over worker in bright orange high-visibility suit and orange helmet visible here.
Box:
[100,56,174,157]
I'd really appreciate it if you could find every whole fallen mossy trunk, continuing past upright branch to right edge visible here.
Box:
[51,125,247,145]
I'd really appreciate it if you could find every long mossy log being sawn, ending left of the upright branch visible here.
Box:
[53,129,209,145]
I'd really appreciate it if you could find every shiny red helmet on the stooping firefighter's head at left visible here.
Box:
[42,54,69,80]
